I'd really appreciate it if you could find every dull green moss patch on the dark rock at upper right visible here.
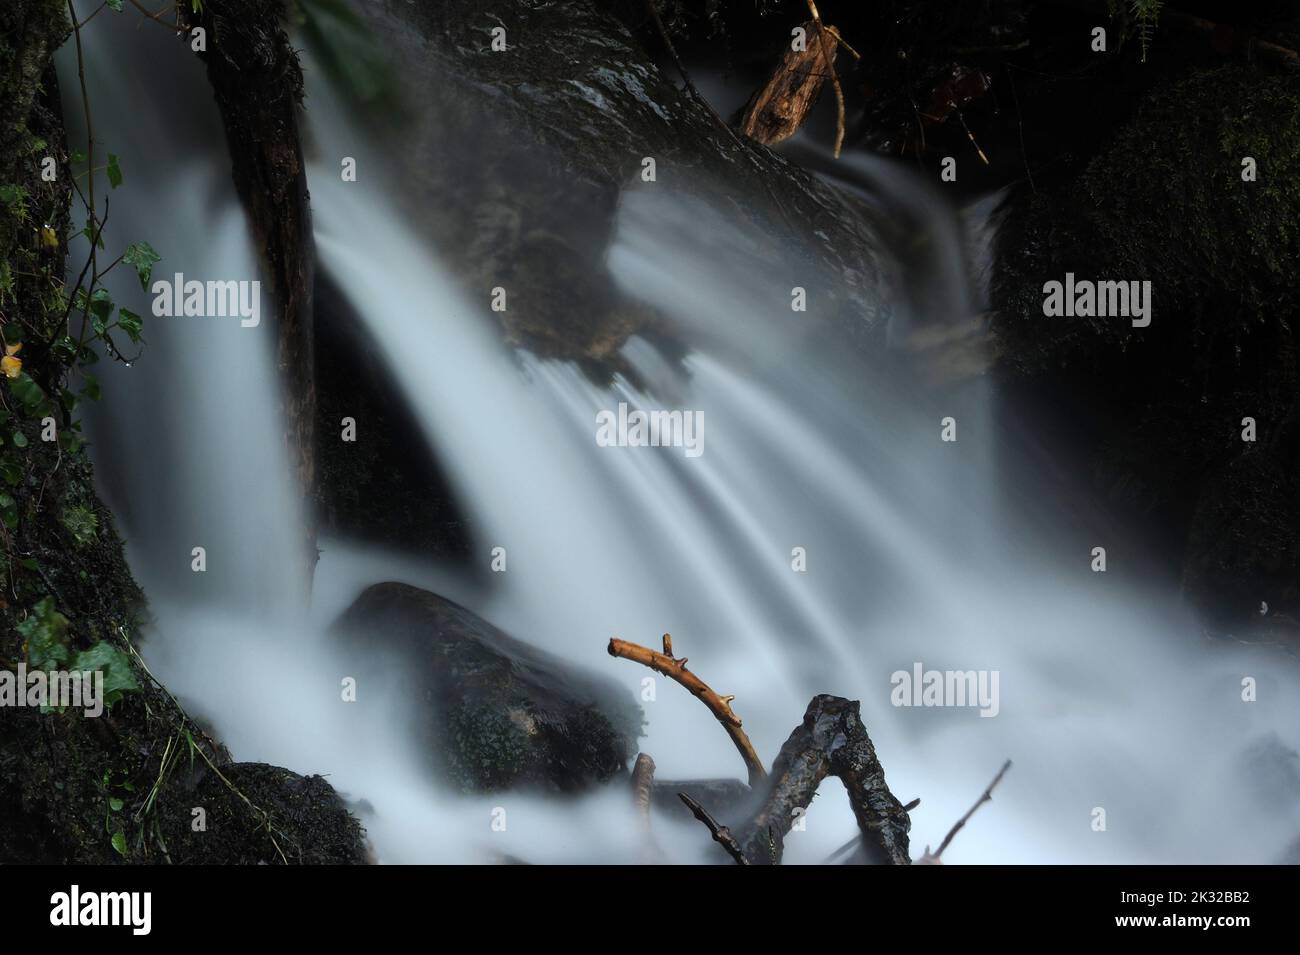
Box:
[1083,66,1300,320]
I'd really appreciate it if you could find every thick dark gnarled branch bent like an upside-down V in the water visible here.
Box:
[738,695,911,865]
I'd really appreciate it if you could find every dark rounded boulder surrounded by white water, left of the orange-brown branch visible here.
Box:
[334,583,641,793]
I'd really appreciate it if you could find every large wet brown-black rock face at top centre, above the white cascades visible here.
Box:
[330,0,880,379]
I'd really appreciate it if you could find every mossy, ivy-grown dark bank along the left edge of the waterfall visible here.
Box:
[0,0,364,864]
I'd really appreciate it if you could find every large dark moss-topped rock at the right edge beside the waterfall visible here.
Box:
[993,65,1300,639]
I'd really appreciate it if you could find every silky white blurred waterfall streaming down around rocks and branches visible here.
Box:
[60,1,1300,863]
